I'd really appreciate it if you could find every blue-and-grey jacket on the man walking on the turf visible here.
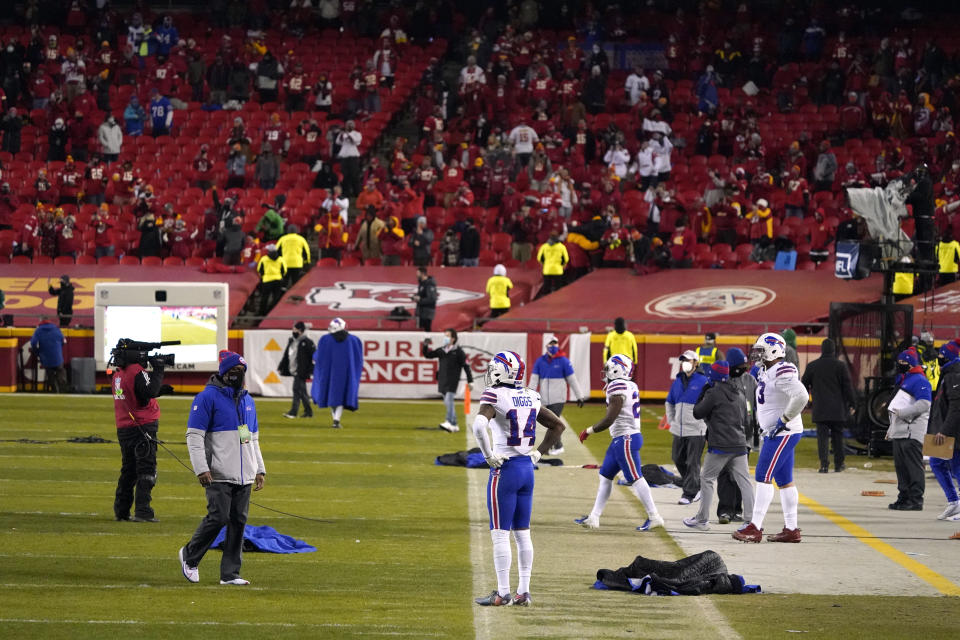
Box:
[187,375,266,484]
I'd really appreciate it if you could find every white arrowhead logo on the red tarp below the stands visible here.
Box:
[305,282,484,311]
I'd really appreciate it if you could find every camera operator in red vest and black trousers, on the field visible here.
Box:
[111,339,173,522]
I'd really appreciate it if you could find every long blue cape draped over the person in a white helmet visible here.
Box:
[310,333,363,411]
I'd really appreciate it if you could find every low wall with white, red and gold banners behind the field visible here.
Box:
[0,328,822,400]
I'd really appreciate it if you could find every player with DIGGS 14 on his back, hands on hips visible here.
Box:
[473,351,563,607]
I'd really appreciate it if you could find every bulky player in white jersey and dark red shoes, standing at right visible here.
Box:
[733,333,809,542]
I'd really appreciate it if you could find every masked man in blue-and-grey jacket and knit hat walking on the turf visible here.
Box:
[178,351,266,585]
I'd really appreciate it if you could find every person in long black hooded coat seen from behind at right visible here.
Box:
[800,338,856,473]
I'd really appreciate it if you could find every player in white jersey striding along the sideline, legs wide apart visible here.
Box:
[574,354,663,531]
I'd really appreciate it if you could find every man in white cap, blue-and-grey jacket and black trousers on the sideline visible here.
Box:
[665,350,707,504]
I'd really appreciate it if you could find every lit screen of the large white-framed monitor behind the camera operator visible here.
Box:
[103,306,218,364]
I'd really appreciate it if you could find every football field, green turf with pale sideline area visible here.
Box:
[0,394,960,640]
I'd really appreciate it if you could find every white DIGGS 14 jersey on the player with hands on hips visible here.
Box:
[480,385,540,458]
